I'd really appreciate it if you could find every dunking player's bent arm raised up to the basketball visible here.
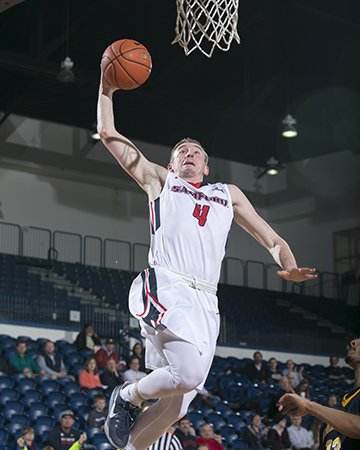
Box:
[97,77,167,197]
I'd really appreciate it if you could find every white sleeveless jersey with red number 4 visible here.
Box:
[149,171,233,285]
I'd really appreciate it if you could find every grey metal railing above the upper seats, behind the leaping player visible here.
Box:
[0,221,342,298]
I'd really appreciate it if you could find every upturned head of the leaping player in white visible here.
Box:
[169,142,209,180]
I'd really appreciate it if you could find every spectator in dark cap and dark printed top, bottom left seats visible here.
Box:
[47,409,87,450]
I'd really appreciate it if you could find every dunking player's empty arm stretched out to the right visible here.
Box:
[228,184,317,282]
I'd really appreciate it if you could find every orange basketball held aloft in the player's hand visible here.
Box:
[101,39,152,90]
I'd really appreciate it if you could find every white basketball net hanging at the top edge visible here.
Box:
[172,0,240,58]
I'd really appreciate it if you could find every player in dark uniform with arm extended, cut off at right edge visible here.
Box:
[278,338,360,450]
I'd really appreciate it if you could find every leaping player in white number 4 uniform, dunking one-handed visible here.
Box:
[98,74,316,450]
